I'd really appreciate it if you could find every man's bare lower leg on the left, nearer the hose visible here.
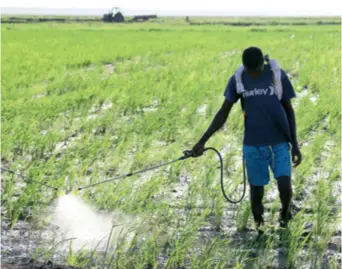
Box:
[250,185,264,232]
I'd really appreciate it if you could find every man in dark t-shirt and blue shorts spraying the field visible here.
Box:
[190,47,302,234]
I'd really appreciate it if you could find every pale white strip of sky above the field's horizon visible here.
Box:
[1,0,342,16]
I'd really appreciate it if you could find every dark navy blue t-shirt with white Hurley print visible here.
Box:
[224,64,296,146]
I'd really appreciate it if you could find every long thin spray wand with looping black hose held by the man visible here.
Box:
[1,147,246,204]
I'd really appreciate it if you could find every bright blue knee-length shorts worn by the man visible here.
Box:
[243,143,291,186]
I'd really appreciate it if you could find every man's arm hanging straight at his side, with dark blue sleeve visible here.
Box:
[281,70,302,167]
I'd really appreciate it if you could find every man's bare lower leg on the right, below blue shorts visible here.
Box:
[277,176,292,227]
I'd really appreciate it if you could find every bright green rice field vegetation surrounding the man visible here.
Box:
[1,17,341,268]
